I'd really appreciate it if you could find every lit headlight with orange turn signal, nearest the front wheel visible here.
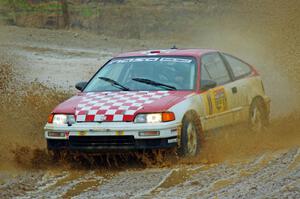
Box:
[134,112,175,123]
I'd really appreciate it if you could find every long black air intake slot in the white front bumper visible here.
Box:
[69,136,135,146]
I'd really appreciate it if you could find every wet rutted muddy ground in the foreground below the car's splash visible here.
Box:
[0,148,300,198]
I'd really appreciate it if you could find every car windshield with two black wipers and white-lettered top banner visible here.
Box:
[84,56,197,92]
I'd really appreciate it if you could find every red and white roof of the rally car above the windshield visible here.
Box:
[116,48,218,58]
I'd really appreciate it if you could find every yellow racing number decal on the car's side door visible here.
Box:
[206,87,228,115]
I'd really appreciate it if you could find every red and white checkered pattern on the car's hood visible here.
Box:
[75,91,169,122]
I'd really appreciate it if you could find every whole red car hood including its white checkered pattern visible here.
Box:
[53,91,192,122]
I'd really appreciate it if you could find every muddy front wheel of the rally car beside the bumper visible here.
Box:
[178,112,202,157]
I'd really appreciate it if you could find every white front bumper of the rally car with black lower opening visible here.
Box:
[45,122,180,152]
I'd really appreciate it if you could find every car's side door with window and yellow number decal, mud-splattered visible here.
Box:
[200,52,234,130]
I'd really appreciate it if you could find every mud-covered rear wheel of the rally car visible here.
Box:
[248,98,269,132]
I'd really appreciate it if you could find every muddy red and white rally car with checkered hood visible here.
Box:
[45,49,270,156]
